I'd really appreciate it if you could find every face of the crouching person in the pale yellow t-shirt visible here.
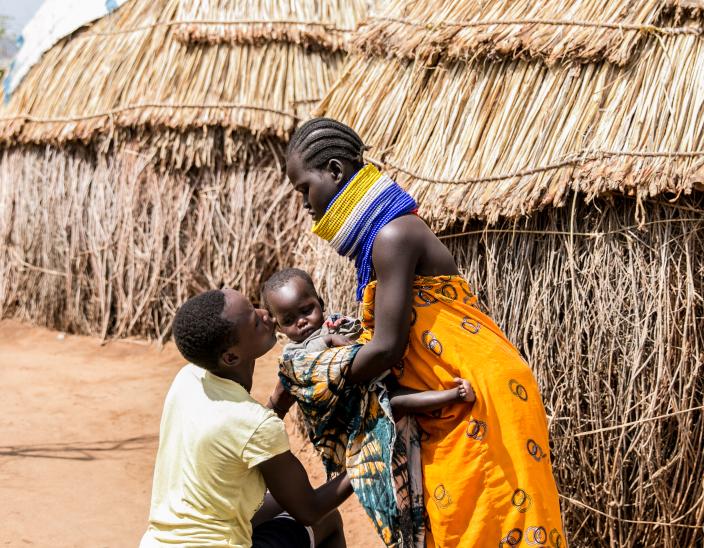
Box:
[221,289,276,363]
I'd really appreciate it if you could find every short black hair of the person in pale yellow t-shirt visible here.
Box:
[173,289,237,371]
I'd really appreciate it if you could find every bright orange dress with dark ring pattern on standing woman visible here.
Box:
[360,276,567,548]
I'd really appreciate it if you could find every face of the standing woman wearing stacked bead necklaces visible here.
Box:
[286,152,347,222]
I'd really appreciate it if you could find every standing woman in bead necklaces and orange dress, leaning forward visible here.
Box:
[286,118,566,547]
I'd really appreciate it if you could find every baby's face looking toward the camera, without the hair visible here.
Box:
[266,278,324,343]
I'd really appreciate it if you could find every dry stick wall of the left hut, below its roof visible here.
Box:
[0,144,303,339]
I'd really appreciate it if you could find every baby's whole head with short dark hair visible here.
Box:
[262,268,325,343]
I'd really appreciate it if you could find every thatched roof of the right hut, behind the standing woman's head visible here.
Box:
[317,0,704,228]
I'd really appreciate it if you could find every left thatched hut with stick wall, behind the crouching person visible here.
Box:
[0,0,366,339]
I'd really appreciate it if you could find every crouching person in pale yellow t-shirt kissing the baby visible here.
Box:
[140,289,352,548]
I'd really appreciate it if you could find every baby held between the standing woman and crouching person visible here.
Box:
[262,268,475,420]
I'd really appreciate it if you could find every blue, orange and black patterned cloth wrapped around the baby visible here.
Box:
[279,344,425,548]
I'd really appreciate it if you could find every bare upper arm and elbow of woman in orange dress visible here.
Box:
[348,217,420,383]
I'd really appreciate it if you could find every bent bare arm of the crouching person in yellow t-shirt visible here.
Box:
[259,451,352,525]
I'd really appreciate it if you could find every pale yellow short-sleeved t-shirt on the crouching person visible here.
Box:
[140,364,289,548]
